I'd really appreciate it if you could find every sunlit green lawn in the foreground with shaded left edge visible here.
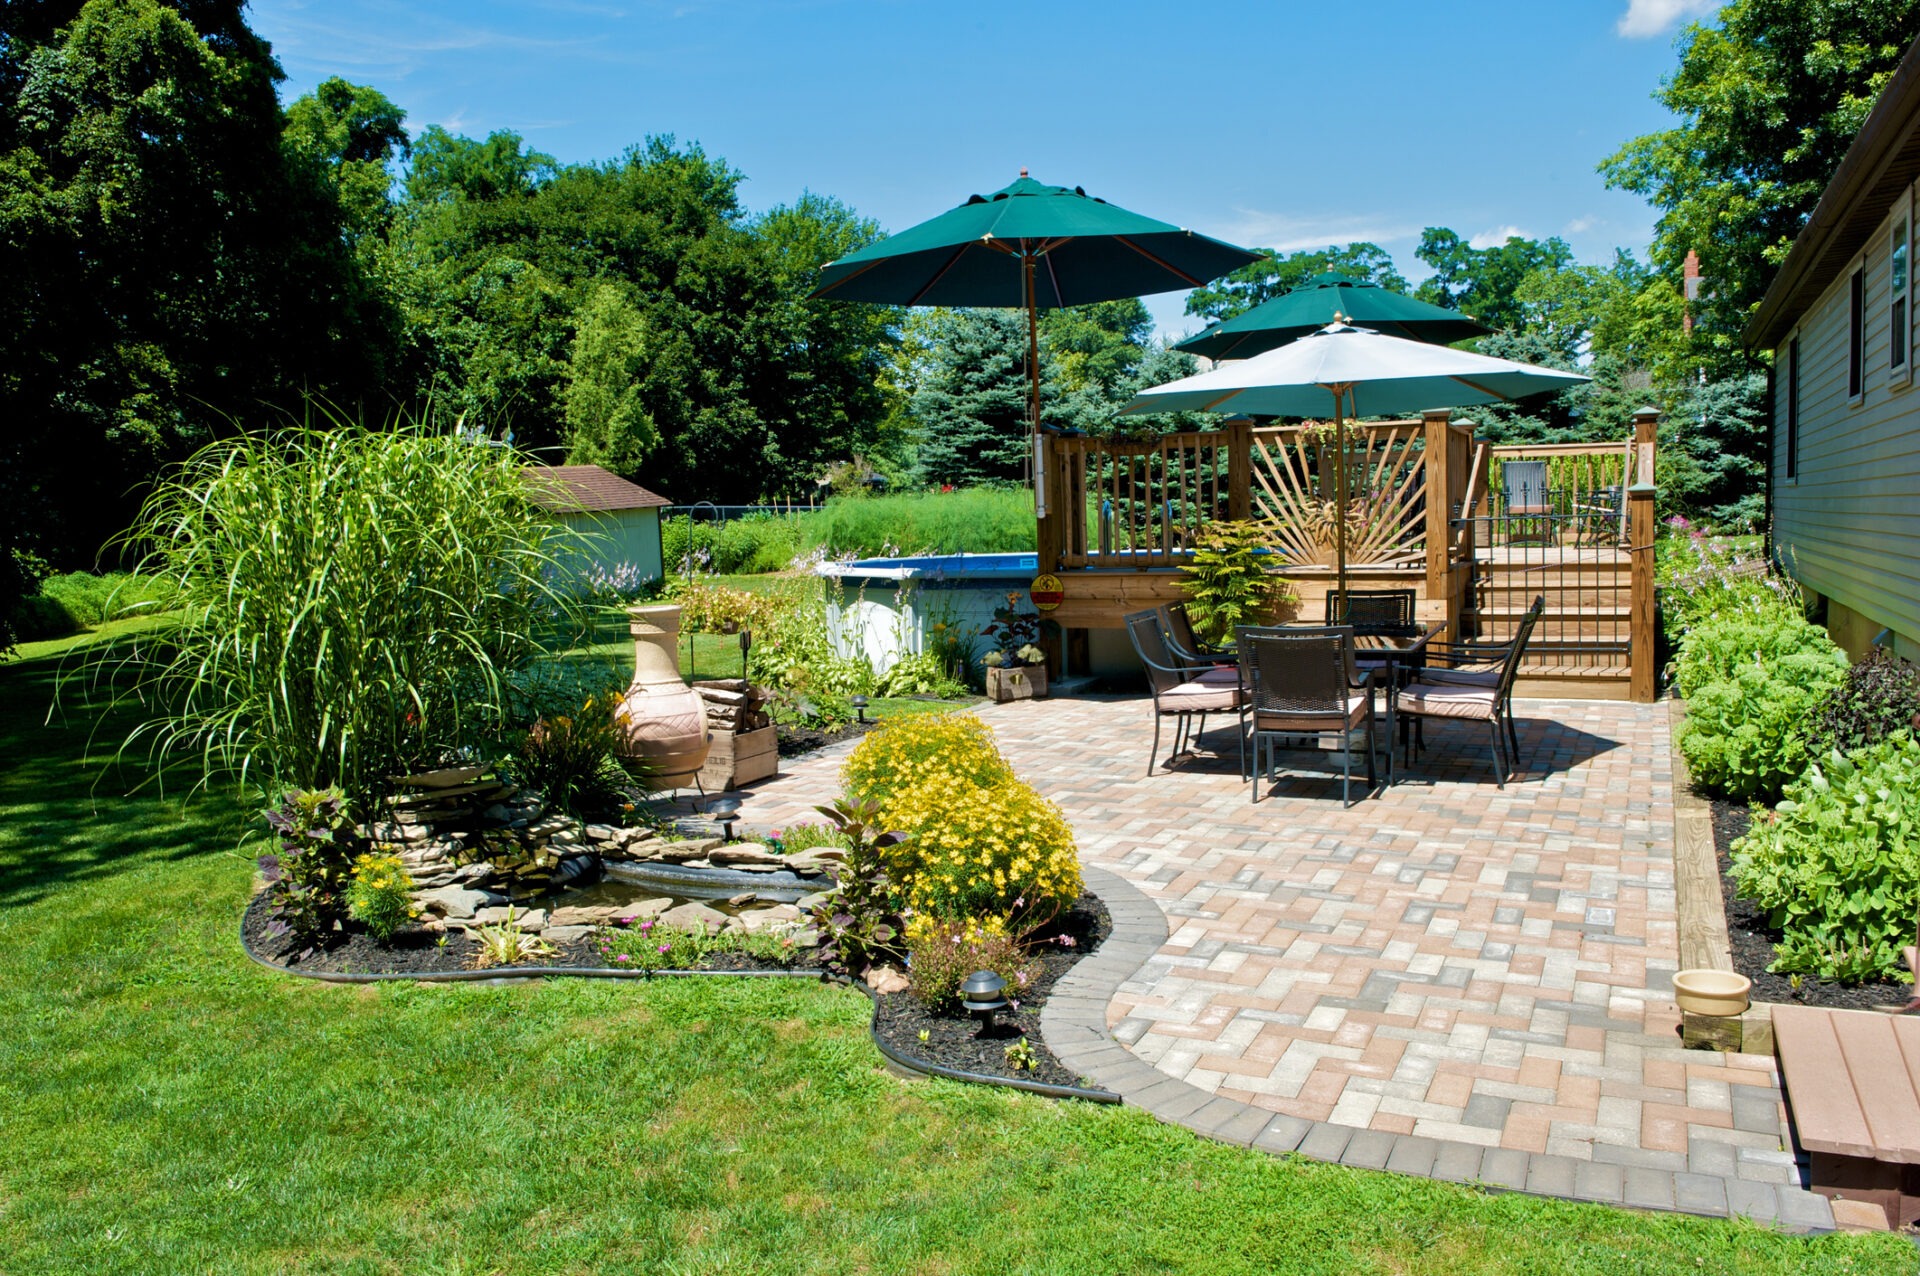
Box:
[0,658,1914,1276]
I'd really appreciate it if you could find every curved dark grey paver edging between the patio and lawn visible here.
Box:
[1041,865,1834,1232]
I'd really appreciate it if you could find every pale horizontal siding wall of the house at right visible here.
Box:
[1772,195,1920,654]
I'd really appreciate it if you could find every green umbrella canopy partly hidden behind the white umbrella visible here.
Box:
[1173,274,1492,359]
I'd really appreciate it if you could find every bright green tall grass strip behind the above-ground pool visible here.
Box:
[801,487,1033,556]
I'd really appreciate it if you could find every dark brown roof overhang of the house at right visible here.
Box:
[1741,38,1920,349]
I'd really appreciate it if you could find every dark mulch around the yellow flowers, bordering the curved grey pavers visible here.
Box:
[874,894,1114,1088]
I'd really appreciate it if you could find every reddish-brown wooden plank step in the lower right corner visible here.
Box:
[1774,1005,1920,1228]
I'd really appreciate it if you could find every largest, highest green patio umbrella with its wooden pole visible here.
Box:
[812,169,1260,458]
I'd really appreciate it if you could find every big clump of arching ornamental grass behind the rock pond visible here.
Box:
[108,426,570,810]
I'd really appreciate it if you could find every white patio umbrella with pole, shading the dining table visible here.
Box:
[1119,324,1590,603]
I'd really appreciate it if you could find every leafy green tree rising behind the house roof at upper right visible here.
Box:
[1599,0,1920,366]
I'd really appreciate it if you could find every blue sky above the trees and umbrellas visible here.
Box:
[250,0,1715,334]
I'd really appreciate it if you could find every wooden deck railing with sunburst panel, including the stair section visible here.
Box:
[1037,411,1657,700]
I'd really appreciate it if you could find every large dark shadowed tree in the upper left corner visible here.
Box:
[0,0,382,637]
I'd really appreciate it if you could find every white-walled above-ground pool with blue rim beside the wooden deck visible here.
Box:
[816,555,1041,673]
